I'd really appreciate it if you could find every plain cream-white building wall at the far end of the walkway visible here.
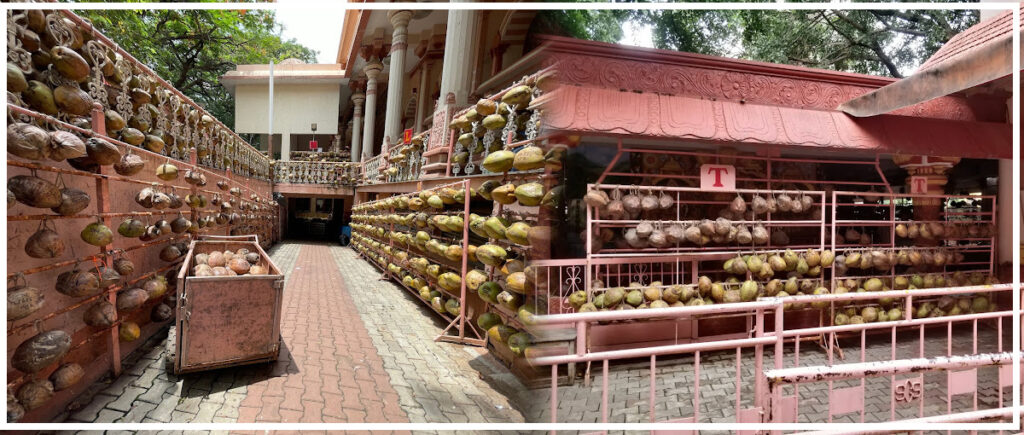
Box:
[234,83,341,161]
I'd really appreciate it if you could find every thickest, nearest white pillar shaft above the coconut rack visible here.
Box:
[437,9,479,107]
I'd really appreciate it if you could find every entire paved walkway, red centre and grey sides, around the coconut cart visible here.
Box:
[65,243,523,423]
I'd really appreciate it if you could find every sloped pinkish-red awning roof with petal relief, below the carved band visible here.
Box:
[535,86,1013,159]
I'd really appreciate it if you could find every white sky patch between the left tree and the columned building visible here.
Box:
[276,0,345,63]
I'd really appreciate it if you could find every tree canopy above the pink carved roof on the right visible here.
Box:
[535,10,978,78]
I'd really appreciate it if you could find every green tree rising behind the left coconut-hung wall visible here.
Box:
[76,9,316,127]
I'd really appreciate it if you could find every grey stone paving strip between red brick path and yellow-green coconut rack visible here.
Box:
[331,247,528,423]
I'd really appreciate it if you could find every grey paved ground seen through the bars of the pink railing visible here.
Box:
[526,315,1012,423]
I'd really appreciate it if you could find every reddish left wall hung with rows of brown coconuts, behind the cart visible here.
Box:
[7,10,280,422]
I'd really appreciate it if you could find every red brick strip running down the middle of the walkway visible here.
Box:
[230,240,409,423]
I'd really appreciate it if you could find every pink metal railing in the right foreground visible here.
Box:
[531,285,1018,423]
